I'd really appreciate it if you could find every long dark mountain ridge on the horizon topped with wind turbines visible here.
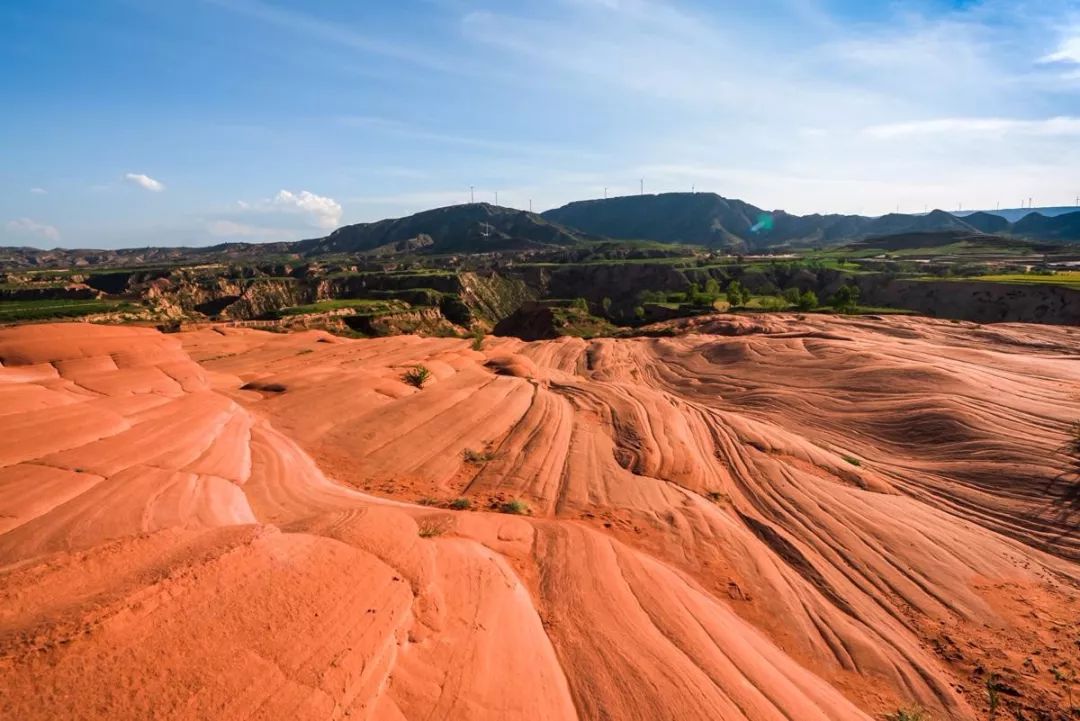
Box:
[6,193,1080,269]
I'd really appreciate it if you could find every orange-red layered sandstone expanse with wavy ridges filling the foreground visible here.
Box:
[0,315,1080,721]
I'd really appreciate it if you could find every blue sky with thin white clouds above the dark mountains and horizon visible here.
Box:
[0,0,1080,247]
